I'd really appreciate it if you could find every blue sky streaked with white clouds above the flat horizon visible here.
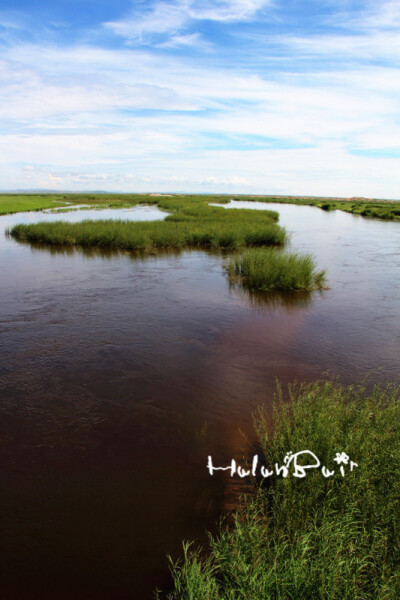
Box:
[0,0,400,198]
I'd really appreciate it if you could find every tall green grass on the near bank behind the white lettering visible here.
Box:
[162,382,400,600]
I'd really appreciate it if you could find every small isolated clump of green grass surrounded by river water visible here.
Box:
[227,248,326,292]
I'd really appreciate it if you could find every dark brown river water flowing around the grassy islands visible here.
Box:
[0,203,400,600]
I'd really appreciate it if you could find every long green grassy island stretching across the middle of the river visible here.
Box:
[11,198,286,251]
